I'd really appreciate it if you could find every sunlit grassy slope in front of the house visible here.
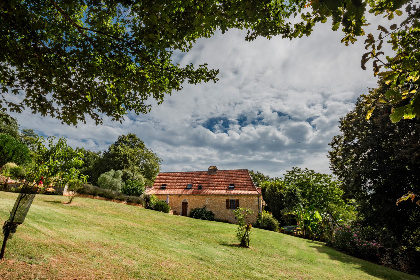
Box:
[0,192,419,279]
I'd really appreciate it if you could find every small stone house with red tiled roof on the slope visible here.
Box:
[147,166,263,223]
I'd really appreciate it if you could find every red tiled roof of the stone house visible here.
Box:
[147,169,261,195]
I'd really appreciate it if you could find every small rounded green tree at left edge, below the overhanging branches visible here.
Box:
[0,133,30,167]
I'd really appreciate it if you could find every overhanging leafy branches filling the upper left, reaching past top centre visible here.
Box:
[0,0,303,124]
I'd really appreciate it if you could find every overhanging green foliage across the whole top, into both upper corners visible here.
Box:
[0,0,420,124]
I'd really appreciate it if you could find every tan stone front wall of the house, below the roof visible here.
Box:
[156,194,262,223]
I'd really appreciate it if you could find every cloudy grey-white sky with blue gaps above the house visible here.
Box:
[11,19,384,177]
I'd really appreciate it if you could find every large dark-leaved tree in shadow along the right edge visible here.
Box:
[329,83,420,249]
